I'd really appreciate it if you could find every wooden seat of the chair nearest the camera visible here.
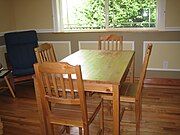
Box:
[50,97,102,127]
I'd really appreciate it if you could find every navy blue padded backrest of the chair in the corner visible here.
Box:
[4,30,38,76]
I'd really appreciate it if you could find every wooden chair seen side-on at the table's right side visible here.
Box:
[103,44,152,134]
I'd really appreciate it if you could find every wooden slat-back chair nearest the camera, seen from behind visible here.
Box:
[34,62,104,135]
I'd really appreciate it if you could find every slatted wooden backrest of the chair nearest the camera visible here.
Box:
[34,62,88,122]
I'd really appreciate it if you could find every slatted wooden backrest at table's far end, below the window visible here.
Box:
[98,34,123,50]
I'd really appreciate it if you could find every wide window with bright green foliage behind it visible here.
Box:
[52,0,164,31]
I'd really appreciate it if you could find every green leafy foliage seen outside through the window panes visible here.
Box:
[75,0,157,29]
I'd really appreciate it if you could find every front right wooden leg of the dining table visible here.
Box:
[113,85,120,135]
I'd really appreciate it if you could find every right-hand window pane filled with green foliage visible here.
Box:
[109,0,157,28]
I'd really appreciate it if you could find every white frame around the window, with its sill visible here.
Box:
[52,0,166,32]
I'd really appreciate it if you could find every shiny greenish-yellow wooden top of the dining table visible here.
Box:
[62,50,134,84]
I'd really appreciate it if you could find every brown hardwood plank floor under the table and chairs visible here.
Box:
[0,80,180,135]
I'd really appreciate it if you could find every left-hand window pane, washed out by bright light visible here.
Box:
[62,0,105,29]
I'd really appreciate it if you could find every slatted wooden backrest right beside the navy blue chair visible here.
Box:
[34,43,57,63]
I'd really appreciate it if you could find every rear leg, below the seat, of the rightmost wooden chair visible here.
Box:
[135,102,140,135]
